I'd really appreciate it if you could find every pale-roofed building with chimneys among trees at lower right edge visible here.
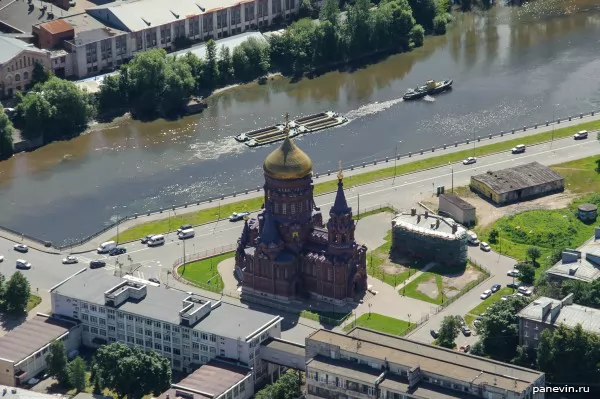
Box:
[517,294,600,348]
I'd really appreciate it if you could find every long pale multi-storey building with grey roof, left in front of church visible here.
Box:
[51,269,281,383]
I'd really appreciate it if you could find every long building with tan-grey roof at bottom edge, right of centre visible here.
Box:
[306,328,545,399]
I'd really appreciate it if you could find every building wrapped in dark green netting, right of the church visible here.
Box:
[392,208,468,266]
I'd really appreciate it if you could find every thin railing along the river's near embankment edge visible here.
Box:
[0,111,600,250]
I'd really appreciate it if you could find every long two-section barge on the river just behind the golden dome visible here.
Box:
[234,111,348,147]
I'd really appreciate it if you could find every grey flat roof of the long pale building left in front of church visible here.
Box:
[52,269,280,340]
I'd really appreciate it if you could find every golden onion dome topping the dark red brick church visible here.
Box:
[263,136,312,180]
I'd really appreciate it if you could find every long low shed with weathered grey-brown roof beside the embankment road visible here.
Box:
[471,162,565,205]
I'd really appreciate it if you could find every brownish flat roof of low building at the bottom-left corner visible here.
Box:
[0,315,75,363]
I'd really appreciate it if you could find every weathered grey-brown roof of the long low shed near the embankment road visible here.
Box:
[471,162,564,194]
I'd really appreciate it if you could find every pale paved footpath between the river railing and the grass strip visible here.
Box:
[0,112,600,253]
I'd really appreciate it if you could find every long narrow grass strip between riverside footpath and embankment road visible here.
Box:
[113,121,600,242]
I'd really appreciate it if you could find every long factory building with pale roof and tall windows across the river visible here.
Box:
[33,0,300,77]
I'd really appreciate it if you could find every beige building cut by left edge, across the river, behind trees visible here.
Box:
[0,36,50,97]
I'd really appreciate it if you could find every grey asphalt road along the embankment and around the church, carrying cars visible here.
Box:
[0,137,600,342]
